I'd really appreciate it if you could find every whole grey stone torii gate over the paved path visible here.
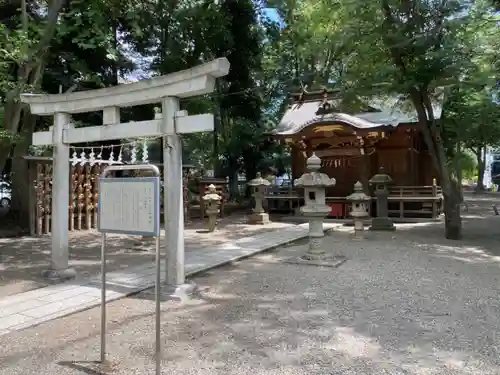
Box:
[21,58,229,294]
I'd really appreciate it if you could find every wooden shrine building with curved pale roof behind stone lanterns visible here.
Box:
[271,89,442,217]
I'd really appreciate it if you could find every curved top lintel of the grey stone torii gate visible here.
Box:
[21,58,229,116]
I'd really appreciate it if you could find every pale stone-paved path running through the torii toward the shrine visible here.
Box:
[0,224,337,336]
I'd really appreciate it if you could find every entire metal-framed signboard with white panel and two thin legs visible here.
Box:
[98,164,161,375]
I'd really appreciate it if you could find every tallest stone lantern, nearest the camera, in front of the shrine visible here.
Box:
[295,153,335,260]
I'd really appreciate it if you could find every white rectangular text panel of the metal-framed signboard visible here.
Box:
[98,177,160,236]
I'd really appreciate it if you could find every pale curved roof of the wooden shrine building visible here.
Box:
[272,93,442,135]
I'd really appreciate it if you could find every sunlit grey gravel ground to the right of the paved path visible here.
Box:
[0,213,500,375]
